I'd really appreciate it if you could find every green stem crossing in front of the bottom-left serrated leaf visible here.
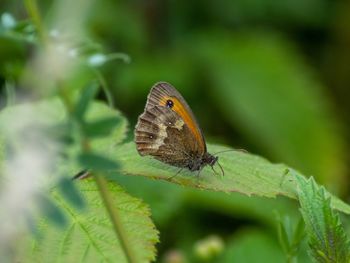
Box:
[94,174,137,263]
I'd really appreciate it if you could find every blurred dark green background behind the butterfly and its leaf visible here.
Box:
[0,0,350,262]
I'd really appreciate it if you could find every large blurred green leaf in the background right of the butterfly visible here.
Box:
[193,31,347,195]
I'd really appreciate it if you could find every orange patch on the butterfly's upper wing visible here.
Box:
[160,97,205,151]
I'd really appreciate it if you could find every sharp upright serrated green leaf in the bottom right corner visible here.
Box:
[296,176,350,263]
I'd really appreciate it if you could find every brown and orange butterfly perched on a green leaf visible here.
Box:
[135,82,221,175]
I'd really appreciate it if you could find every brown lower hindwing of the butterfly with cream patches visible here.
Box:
[135,106,203,167]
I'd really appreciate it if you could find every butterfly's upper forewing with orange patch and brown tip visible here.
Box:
[145,82,207,153]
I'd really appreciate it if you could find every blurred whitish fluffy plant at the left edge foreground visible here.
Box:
[0,107,59,260]
